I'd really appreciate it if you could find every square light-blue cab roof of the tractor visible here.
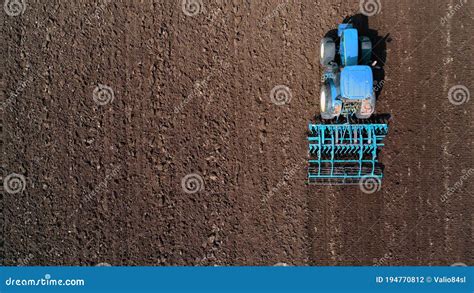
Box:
[341,65,374,100]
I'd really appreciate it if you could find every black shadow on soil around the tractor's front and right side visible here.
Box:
[325,14,392,101]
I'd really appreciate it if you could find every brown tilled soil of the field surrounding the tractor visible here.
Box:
[0,0,474,265]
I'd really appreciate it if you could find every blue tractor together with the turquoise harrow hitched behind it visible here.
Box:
[308,23,388,184]
